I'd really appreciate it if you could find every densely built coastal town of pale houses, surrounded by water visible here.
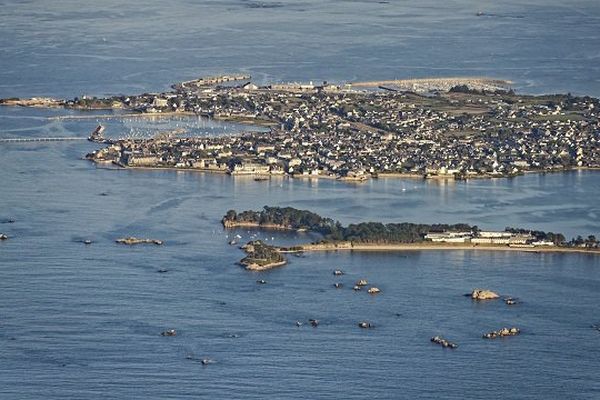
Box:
[0,75,600,181]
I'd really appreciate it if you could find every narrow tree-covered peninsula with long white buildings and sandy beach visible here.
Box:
[222,206,600,269]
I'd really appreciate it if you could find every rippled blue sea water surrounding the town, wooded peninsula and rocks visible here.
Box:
[0,1,600,400]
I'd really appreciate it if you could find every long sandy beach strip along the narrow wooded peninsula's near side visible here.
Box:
[298,242,600,256]
